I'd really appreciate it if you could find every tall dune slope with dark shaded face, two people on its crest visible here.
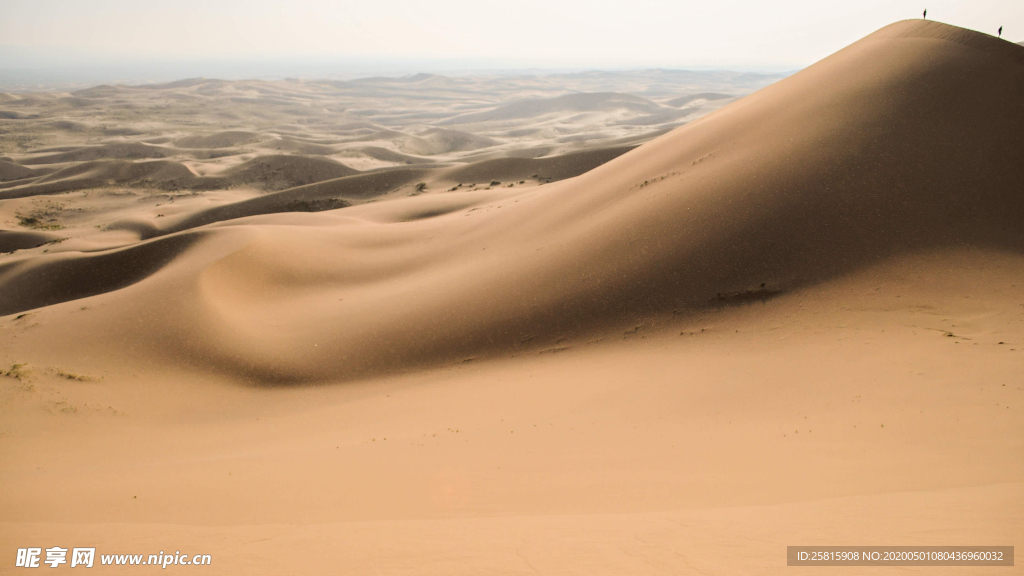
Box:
[0,20,1024,383]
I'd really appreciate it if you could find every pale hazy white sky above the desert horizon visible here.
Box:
[0,0,1024,68]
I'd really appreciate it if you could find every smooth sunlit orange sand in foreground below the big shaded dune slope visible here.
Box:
[0,243,1024,575]
